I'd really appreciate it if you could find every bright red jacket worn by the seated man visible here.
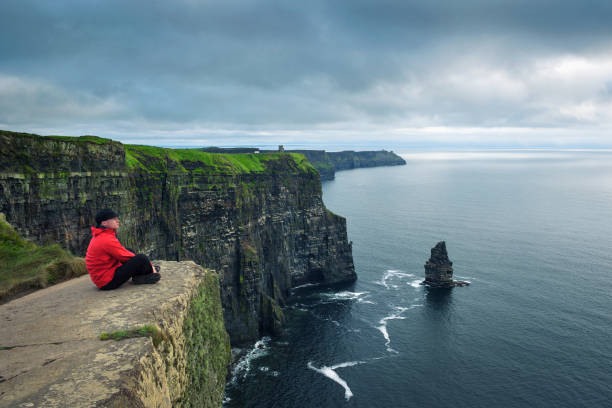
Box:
[85,227,134,288]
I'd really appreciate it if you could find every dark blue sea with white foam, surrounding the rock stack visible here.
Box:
[225,151,612,408]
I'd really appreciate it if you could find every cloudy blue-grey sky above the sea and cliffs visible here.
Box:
[0,0,612,149]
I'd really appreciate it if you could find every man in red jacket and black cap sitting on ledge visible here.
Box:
[85,209,160,290]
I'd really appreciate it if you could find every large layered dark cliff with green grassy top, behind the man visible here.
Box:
[0,132,356,344]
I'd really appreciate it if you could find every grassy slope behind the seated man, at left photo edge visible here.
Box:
[0,214,87,303]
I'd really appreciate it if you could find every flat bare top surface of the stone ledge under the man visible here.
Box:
[0,261,204,407]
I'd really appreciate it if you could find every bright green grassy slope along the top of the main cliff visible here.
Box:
[125,145,317,174]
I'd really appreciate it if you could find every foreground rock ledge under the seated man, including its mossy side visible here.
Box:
[0,261,230,407]
